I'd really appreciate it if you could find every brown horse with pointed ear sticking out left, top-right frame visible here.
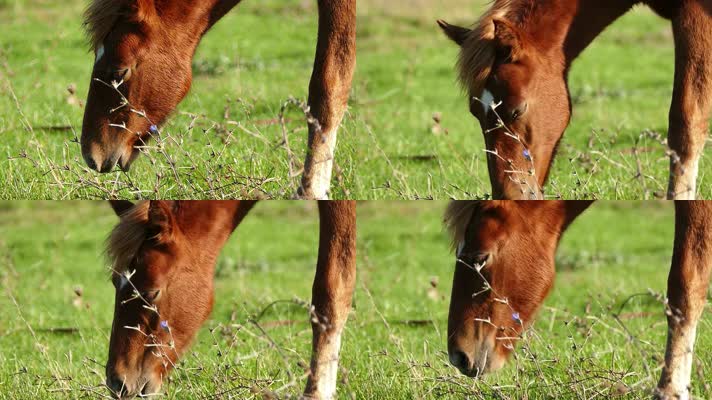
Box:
[438,0,712,199]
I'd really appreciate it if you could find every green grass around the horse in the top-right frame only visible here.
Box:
[355,0,712,199]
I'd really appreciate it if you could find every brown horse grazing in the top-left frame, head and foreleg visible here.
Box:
[81,0,356,199]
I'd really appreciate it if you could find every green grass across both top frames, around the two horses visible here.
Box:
[0,0,712,199]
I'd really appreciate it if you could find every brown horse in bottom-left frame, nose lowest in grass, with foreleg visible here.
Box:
[101,201,356,399]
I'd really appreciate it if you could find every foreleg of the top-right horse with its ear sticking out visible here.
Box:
[668,0,712,200]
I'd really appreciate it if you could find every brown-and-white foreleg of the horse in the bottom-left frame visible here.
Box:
[304,201,356,399]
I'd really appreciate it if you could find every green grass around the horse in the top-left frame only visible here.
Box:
[0,0,354,199]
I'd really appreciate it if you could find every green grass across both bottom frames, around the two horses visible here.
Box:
[0,202,712,399]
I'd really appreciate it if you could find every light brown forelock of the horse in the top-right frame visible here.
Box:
[457,0,523,96]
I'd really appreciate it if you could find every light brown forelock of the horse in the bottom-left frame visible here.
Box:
[105,201,150,273]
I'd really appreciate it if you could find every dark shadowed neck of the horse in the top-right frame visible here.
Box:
[557,0,640,65]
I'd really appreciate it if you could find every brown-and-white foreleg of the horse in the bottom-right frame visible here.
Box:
[656,201,712,399]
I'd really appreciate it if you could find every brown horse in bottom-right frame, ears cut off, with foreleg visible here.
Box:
[445,201,712,399]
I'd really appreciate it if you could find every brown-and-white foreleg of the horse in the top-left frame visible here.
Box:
[297,0,356,199]
